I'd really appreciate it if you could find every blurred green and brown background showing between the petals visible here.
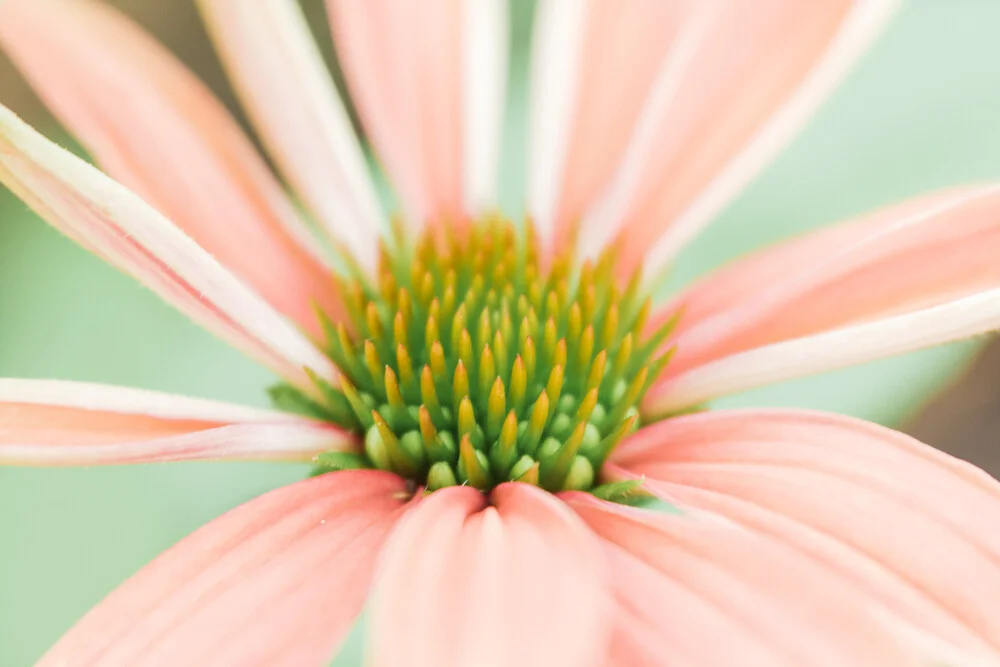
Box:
[0,0,1000,665]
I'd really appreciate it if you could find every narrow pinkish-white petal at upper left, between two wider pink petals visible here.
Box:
[199,0,382,271]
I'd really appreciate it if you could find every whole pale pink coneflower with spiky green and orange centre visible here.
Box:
[0,0,1000,666]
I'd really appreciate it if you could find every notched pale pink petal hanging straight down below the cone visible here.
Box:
[370,483,610,667]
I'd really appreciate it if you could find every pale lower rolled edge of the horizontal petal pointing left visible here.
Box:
[0,423,355,466]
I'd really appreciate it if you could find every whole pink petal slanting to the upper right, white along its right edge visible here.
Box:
[608,0,898,275]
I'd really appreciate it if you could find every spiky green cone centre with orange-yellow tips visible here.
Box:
[282,216,673,495]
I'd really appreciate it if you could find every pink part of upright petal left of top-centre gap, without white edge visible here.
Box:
[328,0,463,224]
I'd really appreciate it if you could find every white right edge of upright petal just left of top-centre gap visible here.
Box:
[462,0,510,214]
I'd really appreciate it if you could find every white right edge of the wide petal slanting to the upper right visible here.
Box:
[640,0,901,279]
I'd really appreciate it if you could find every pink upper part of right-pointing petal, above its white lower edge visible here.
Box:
[661,187,1000,373]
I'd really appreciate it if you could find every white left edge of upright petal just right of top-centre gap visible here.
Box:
[528,0,589,243]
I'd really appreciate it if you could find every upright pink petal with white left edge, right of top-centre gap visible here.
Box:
[528,0,689,248]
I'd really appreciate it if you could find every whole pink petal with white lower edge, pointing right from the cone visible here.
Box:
[649,186,1000,406]
